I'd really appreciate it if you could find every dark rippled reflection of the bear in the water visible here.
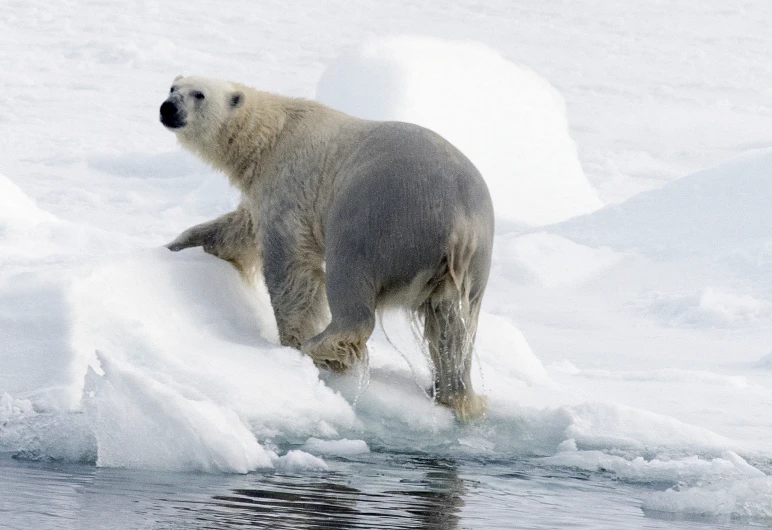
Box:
[199,458,465,530]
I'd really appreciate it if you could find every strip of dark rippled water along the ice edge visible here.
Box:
[0,453,760,530]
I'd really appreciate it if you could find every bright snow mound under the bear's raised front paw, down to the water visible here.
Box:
[71,249,353,462]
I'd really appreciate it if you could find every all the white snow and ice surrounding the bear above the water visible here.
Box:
[0,0,772,518]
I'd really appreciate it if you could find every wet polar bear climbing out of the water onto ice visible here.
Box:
[160,76,494,421]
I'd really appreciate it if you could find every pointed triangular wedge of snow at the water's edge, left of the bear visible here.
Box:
[85,355,272,473]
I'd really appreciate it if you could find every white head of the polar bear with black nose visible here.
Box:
[160,76,244,143]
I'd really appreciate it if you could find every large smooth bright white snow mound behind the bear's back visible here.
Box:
[316,36,602,225]
